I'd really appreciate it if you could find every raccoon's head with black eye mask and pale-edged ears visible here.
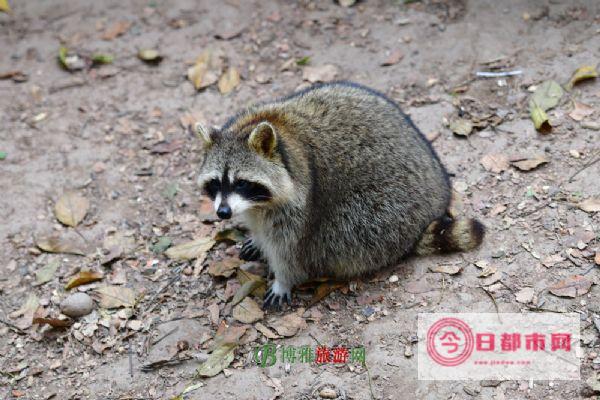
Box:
[196,121,292,219]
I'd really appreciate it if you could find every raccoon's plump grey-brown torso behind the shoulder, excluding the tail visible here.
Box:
[283,83,450,270]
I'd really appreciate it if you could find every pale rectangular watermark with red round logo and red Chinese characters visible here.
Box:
[418,313,580,380]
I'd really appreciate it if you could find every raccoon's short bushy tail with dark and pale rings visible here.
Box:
[414,216,485,255]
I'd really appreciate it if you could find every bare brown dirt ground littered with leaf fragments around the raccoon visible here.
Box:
[0,0,600,400]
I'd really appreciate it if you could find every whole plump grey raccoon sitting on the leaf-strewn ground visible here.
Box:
[196,82,484,308]
